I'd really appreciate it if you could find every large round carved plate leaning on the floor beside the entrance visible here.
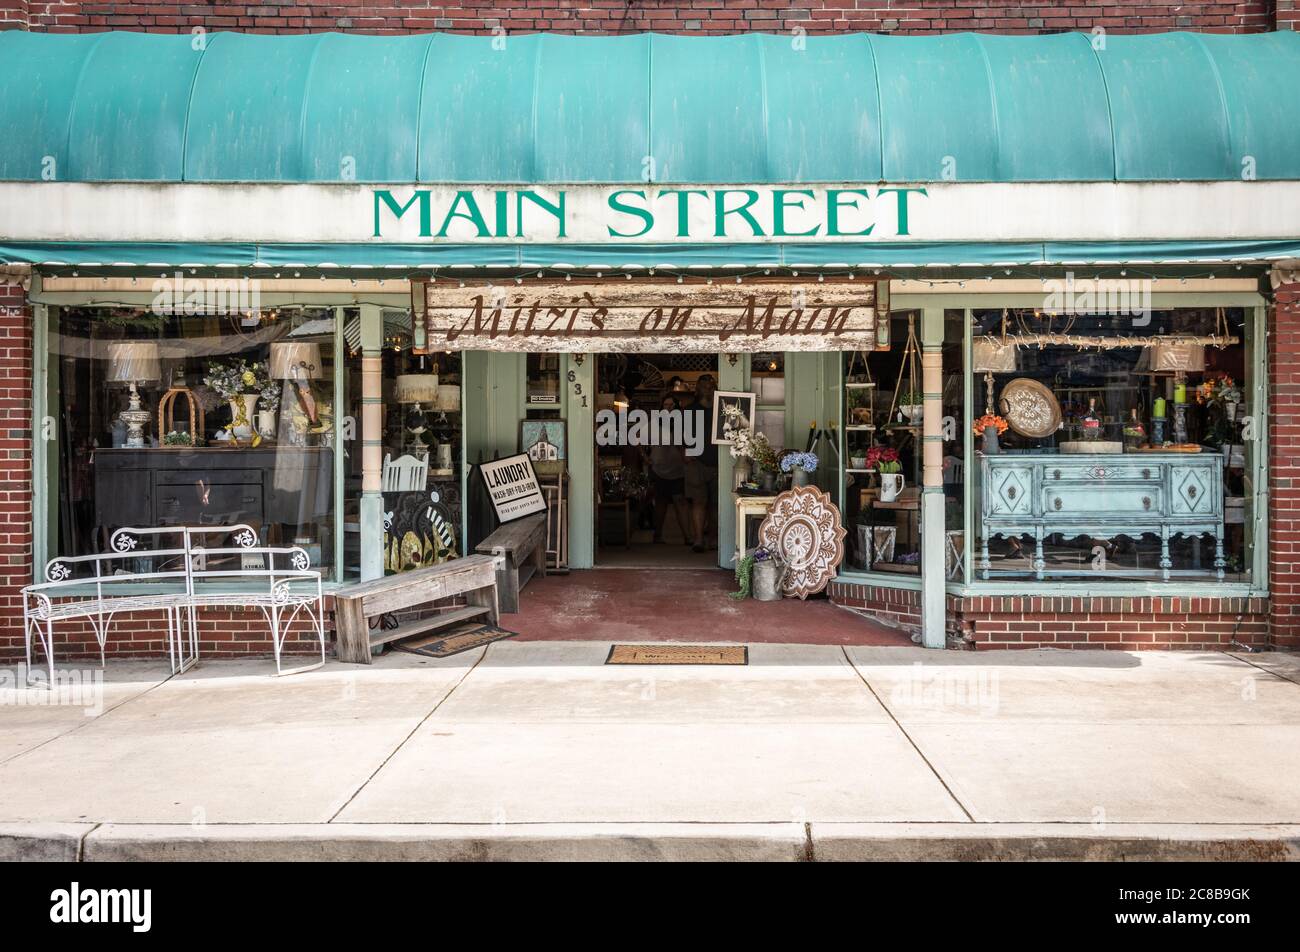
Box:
[758,486,845,598]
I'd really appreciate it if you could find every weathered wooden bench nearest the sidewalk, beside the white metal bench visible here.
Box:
[334,555,498,665]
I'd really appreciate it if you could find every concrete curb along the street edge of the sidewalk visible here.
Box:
[0,823,1300,862]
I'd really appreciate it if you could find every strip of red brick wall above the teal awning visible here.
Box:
[0,0,1297,34]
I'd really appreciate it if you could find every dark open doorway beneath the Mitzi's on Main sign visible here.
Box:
[592,354,720,570]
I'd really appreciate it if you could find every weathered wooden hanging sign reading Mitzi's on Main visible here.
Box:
[423,278,878,354]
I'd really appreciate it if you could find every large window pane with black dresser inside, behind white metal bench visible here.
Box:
[49,307,337,574]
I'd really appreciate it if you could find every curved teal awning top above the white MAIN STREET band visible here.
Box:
[0,31,1300,183]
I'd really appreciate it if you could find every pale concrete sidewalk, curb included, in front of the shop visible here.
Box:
[0,641,1300,860]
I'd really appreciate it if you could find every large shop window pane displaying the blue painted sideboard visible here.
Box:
[971,308,1256,584]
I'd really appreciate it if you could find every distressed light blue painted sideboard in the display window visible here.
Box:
[980,453,1226,580]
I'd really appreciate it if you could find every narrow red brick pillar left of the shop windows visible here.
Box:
[0,284,31,657]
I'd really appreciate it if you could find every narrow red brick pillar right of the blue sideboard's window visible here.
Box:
[1269,285,1300,648]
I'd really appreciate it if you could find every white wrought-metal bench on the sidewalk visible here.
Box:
[22,525,325,684]
